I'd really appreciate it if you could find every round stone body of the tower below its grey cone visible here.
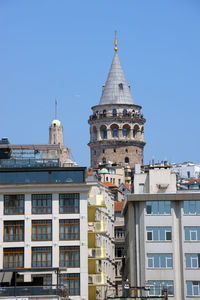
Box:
[89,105,145,168]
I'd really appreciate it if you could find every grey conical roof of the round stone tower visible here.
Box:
[99,50,134,105]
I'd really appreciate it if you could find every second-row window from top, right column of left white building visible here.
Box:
[59,219,80,240]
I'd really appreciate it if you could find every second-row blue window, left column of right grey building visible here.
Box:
[146,227,172,241]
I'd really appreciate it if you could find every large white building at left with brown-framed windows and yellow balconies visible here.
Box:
[0,167,114,300]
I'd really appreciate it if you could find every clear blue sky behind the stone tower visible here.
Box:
[0,0,200,166]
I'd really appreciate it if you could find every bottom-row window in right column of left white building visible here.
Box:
[60,273,80,296]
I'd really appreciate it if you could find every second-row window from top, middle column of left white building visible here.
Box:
[32,220,52,241]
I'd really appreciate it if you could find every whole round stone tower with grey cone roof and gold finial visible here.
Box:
[88,35,146,168]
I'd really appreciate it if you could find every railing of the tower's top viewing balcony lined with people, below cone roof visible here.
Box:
[89,112,145,121]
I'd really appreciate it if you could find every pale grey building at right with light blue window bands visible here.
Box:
[123,164,200,300]
